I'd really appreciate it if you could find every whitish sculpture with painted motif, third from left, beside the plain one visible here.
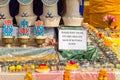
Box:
[40,0,61,27]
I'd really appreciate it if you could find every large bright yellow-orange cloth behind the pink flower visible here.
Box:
[90,0,120,29]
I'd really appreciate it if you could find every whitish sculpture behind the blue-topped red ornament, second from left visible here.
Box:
[16,0,37,26]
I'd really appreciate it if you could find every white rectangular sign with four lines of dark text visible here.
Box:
[59,29,87,50]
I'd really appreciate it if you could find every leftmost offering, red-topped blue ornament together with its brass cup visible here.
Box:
[2,20,14,48]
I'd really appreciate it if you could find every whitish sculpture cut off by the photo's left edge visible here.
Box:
[0,0,12,26]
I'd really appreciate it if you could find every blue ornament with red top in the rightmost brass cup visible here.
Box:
[34,21,44,36]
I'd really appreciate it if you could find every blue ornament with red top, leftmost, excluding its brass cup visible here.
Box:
[3,20,13,36]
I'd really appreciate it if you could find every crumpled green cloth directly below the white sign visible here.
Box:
[59,46,99,61]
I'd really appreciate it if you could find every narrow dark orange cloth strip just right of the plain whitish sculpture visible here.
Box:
[83,1,90,23]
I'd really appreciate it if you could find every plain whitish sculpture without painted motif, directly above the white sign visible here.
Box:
[63,0,83,26]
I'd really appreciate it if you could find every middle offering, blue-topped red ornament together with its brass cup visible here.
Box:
[18,20,30,48]
